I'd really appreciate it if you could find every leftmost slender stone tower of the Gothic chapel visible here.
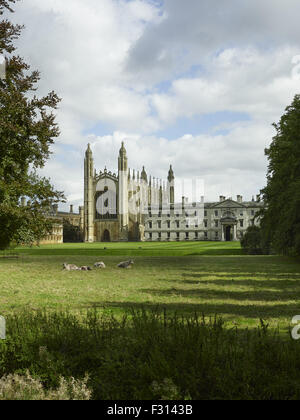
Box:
[84,144,94,242]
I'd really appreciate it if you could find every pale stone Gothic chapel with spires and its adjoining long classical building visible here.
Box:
[79,143,263,242]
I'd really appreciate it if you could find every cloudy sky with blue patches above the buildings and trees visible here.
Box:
[8,0,300,209]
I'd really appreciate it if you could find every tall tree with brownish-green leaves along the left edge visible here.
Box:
[0,0,64,249]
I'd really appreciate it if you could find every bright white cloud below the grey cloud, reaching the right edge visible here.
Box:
[152,47,299,124]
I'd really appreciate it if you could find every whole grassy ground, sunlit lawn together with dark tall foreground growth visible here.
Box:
[0,242,300,400]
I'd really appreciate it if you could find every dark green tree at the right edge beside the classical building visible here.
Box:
[261,95,300,255]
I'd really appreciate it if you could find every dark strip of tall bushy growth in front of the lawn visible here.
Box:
[0,309,300,400]
